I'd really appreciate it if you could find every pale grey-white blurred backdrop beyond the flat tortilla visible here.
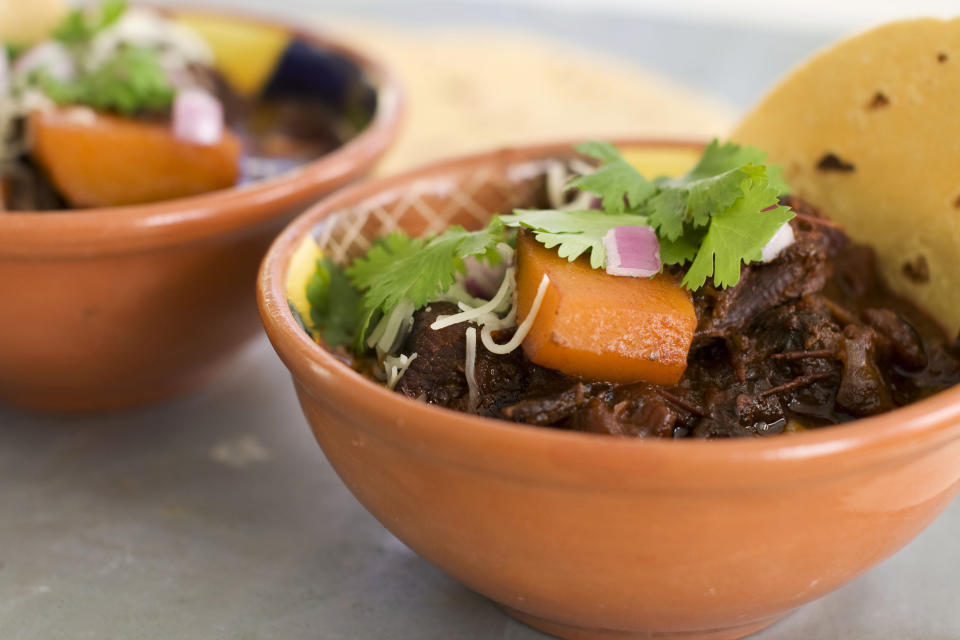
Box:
[197,0,958,108]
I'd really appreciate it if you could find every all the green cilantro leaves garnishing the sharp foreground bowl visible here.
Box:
[307,140,794,352]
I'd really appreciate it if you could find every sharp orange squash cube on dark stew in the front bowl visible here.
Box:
[517,232,697,384]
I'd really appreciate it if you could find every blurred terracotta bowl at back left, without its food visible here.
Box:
[0,11,401,411]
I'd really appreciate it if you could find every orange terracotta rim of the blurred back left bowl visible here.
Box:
[0,3,405,257]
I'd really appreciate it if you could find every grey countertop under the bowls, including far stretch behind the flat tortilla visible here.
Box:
[0,0,960,640]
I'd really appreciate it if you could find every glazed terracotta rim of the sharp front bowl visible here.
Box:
[257,138,960,491]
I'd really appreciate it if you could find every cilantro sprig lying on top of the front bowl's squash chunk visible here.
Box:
[501,140,794,290]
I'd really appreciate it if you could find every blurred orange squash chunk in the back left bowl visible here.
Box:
[30,109,241,207]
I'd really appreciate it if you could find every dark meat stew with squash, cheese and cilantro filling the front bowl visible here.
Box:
[291,142,960,438]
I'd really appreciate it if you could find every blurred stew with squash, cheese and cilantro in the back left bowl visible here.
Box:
[0,0,353,211]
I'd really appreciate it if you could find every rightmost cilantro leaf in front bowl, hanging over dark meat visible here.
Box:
[683,174,794,290]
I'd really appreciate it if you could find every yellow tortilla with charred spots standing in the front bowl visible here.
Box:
[731,19,960,335]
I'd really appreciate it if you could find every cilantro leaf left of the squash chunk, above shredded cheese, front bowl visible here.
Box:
[347,220,504,339]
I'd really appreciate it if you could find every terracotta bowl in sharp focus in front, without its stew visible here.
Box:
[259,143,960,640]
